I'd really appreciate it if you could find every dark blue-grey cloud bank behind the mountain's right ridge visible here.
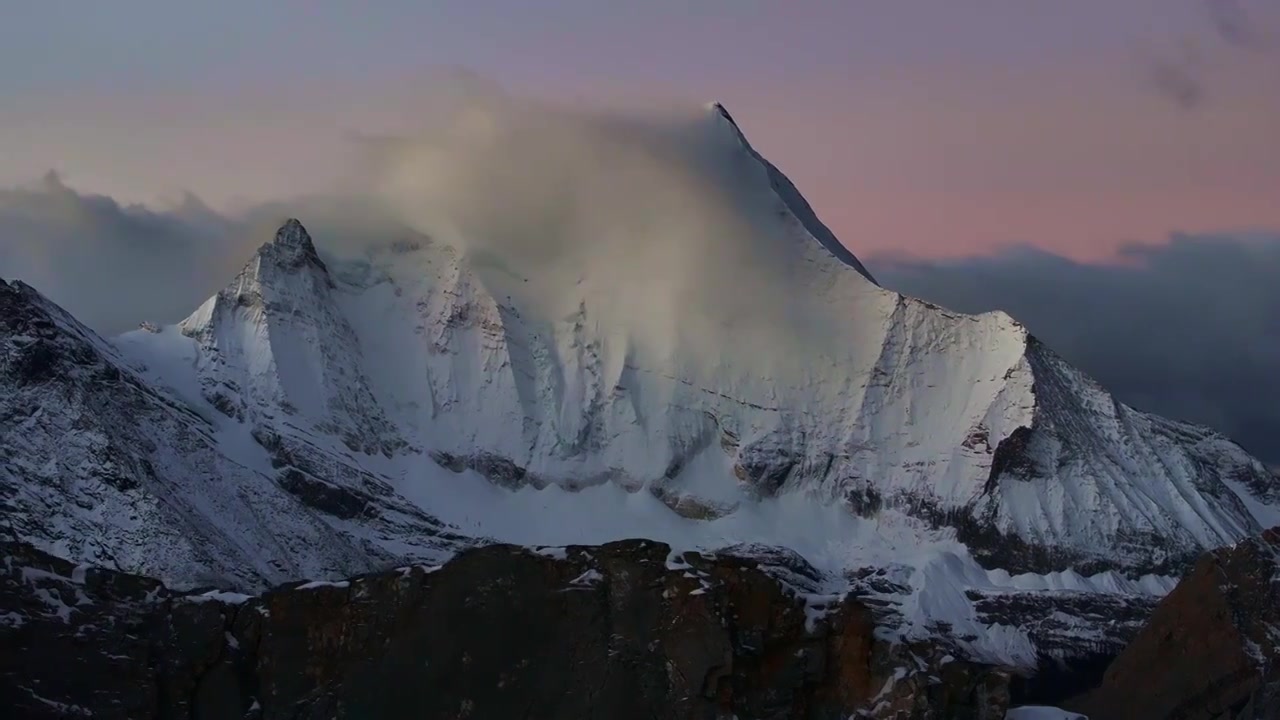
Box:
[869,233,1280,462]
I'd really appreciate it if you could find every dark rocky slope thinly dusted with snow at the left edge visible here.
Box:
[0,274,465,587]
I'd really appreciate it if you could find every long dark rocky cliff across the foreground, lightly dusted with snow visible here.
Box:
[0,541,1009,720]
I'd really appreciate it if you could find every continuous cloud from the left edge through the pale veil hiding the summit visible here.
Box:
[0,87,860,366]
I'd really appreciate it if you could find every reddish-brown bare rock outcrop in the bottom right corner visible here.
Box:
[1074,529,1280,720]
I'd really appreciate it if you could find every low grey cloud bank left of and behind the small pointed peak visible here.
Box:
[0,173,403,336]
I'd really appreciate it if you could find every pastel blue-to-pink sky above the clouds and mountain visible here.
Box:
[0,0,1280,259]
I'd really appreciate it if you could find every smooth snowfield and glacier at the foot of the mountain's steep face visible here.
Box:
[384,456,1126,666]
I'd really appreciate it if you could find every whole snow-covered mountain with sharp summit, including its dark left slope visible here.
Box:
[0,105,1280,665]
